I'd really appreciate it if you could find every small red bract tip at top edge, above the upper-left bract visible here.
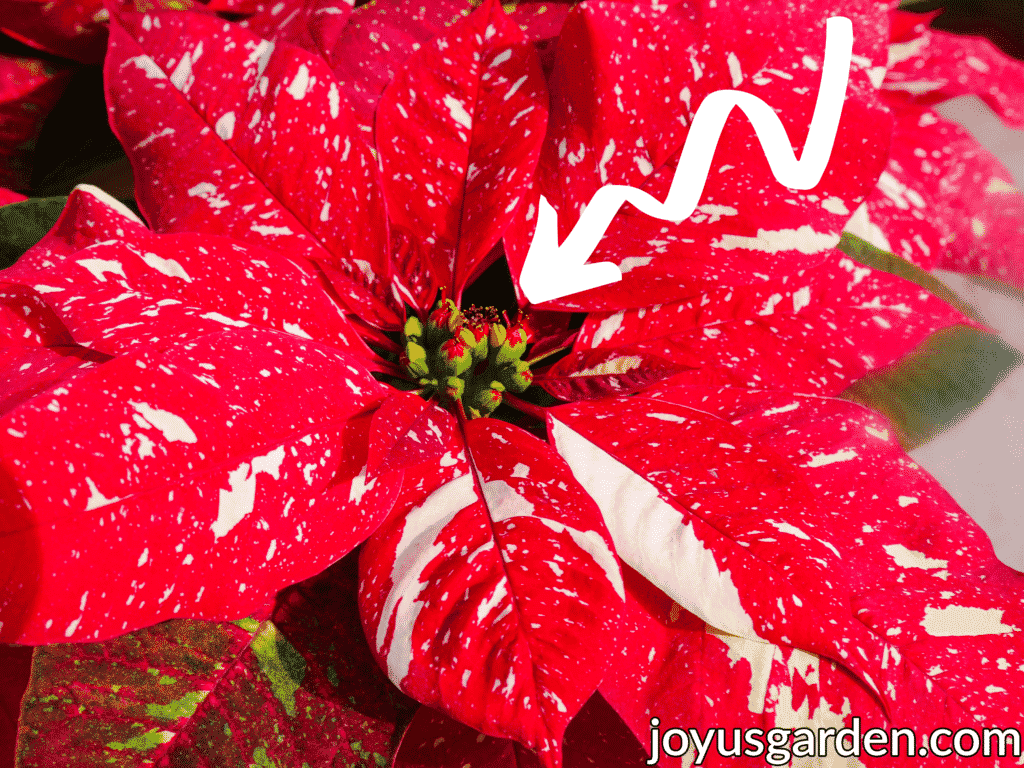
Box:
[239,0,354,60]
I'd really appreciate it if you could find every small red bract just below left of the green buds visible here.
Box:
[367,391,454,476]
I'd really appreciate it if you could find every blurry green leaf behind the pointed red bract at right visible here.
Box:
[839,233,1022,451]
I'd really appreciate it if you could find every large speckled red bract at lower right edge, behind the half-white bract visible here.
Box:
[667,388,1024,741]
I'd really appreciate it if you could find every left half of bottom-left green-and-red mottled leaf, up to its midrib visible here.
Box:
[17,618,272,768]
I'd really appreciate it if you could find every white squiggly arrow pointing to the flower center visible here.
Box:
[519,16,853,304]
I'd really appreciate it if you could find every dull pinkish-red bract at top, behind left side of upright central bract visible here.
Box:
[327,0,473,135]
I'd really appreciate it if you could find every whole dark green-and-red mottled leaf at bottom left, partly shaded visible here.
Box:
[19,555,415,768]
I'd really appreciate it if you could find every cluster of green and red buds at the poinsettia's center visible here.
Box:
[401,298,534,419]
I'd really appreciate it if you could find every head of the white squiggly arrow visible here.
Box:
[519,195,623,304]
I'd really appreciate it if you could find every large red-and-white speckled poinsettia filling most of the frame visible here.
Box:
[0,0,1024,767]
